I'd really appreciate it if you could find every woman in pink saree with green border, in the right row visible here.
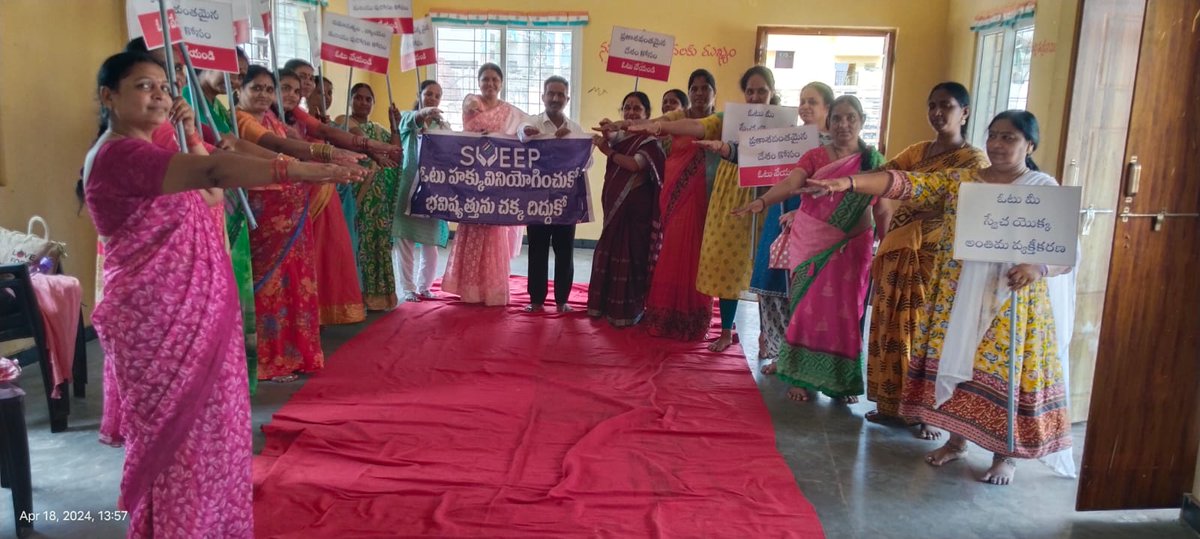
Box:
[734,96,883,402]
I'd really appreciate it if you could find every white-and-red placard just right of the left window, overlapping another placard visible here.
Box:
[320,12,392,73]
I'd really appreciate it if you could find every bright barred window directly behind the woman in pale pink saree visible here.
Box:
[428,24,581,128]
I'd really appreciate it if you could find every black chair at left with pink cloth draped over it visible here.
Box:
[0,264,69,432]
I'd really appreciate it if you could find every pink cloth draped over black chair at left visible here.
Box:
[31,274,83,399]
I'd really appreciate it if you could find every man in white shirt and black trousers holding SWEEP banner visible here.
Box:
[517,76,584,312]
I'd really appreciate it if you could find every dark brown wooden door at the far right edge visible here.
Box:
[1076,0,1200,510]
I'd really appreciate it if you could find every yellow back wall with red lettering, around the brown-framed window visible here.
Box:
[367,0,949,239]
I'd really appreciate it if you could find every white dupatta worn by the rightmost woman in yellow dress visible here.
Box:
[934,170,1075,478]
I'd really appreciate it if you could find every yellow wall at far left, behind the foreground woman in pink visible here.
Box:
[0,0,126,313]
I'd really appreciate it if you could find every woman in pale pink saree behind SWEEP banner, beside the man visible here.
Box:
[442,64,524,306]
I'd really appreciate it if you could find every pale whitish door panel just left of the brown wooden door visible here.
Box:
[1060,0,1146,421]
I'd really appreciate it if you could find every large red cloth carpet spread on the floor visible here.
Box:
[254,277,823,538]
